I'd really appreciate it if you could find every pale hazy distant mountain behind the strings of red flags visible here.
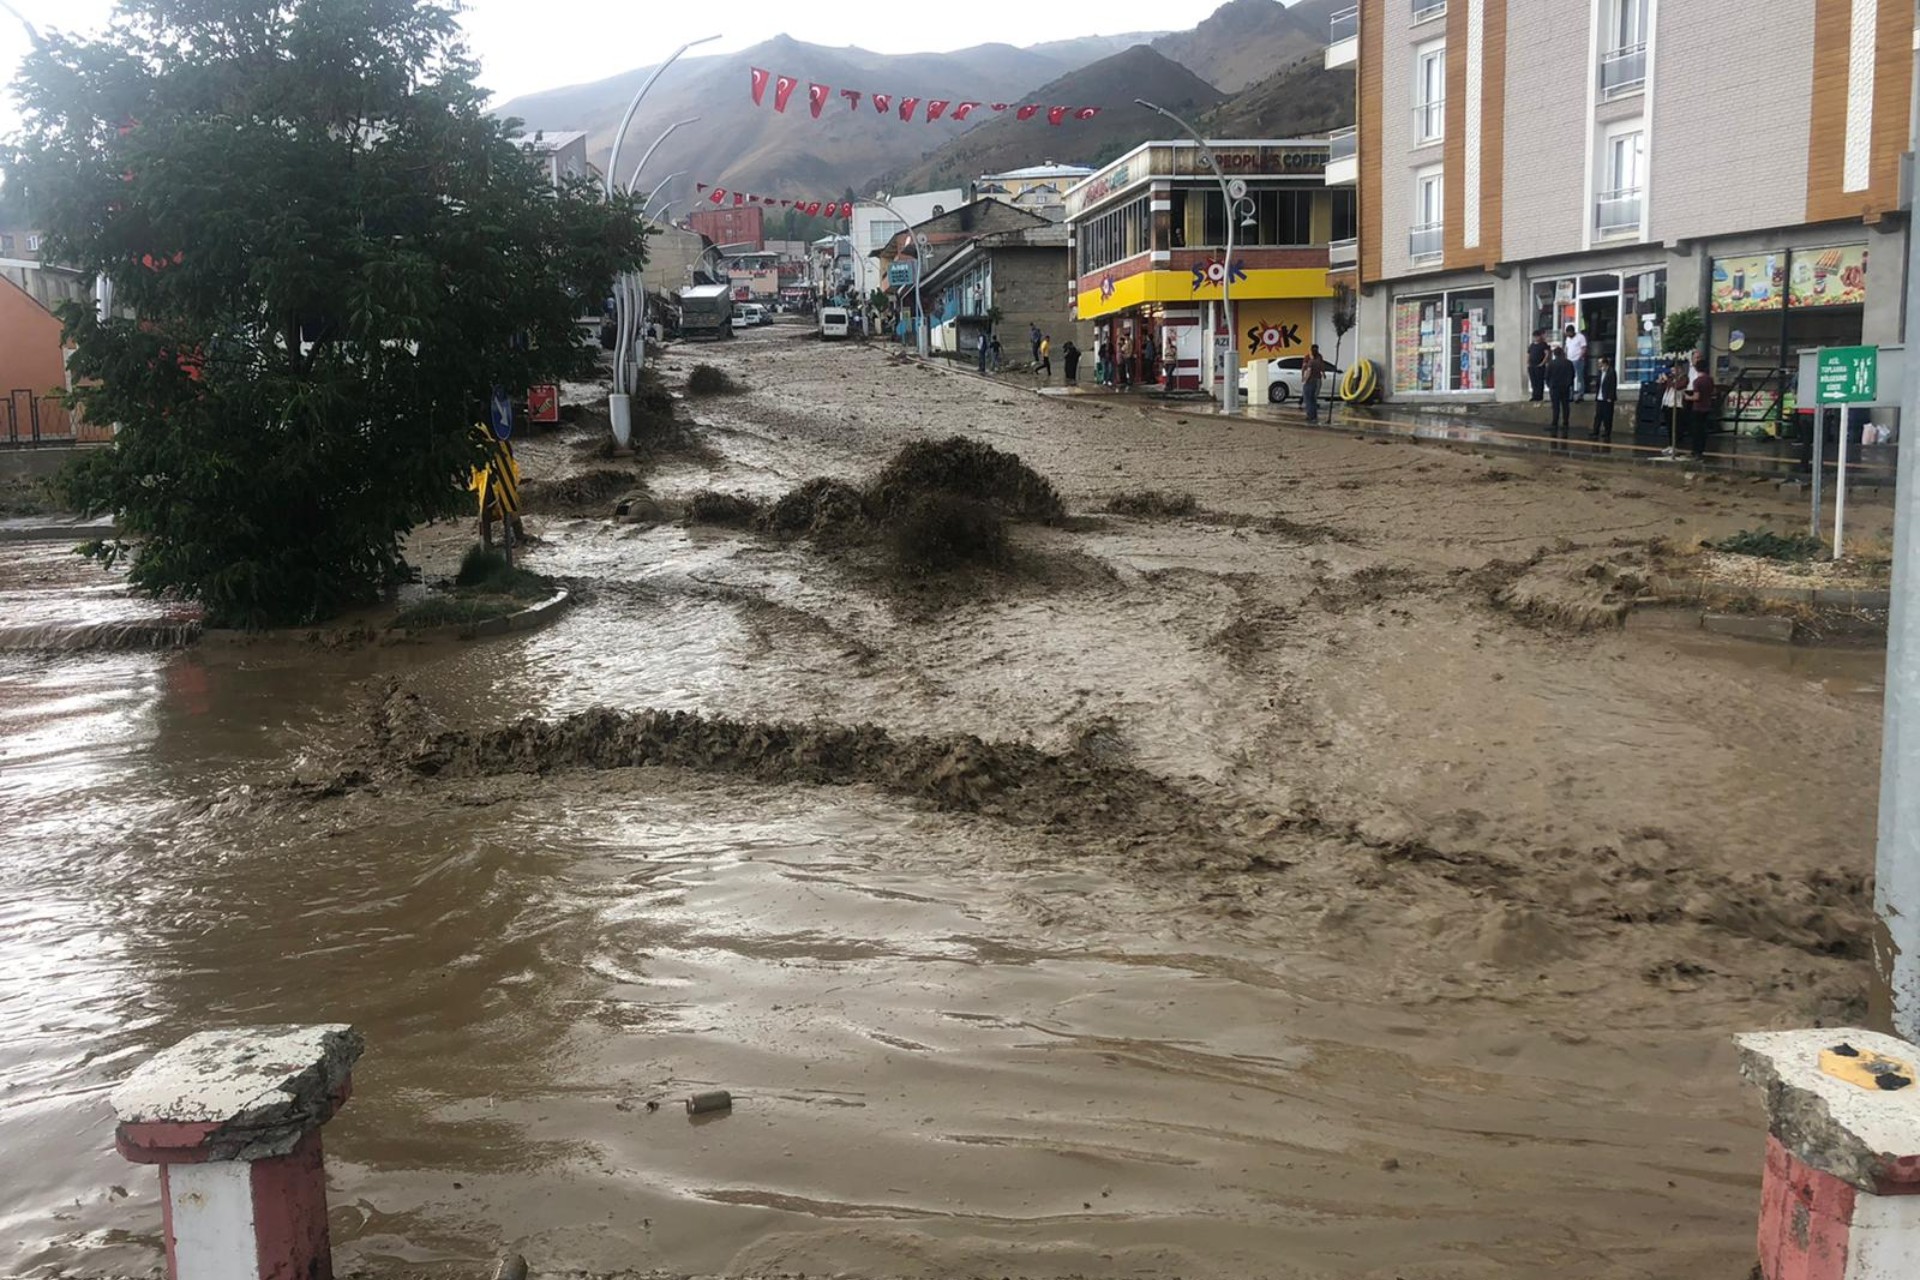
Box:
[497,33,1159,213]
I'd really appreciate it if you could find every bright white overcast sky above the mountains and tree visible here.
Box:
[0,0,1221,134]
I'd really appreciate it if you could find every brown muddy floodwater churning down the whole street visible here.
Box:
[0,326,1887,1280]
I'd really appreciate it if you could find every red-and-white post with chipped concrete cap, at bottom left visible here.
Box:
[111,1023,365,1280]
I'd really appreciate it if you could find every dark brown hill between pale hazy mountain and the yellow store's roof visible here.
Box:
[893,46,1228,190]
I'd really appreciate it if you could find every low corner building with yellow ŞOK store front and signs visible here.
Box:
[1066,138,1354,397]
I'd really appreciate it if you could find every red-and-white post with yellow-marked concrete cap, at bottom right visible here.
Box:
[1736,1027,1920,1280]
